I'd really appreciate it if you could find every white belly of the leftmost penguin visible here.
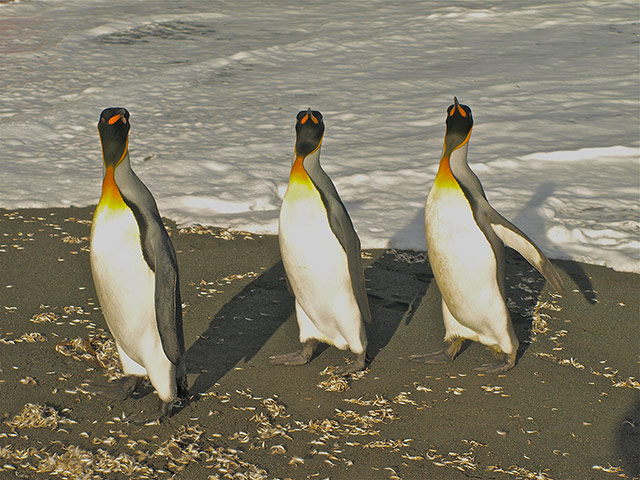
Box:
[91,207,166,375]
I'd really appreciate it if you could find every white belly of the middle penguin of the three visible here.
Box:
[279,184,364,351]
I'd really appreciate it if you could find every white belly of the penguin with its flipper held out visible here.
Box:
[425,188,507,336]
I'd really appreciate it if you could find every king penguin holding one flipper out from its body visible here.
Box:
[412,97,564,373]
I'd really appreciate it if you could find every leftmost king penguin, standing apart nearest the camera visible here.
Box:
[90,108,189,420]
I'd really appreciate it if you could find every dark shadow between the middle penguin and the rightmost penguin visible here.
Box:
[365,209,433,361]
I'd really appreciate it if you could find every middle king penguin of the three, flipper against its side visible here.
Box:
[270,108,371,374]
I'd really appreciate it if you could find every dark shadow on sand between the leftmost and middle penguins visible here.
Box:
[186,261,294,401]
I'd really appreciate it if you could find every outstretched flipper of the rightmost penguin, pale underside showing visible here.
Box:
[488,209,564,295]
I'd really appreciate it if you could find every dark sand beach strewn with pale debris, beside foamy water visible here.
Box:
[0,208,640,479]
